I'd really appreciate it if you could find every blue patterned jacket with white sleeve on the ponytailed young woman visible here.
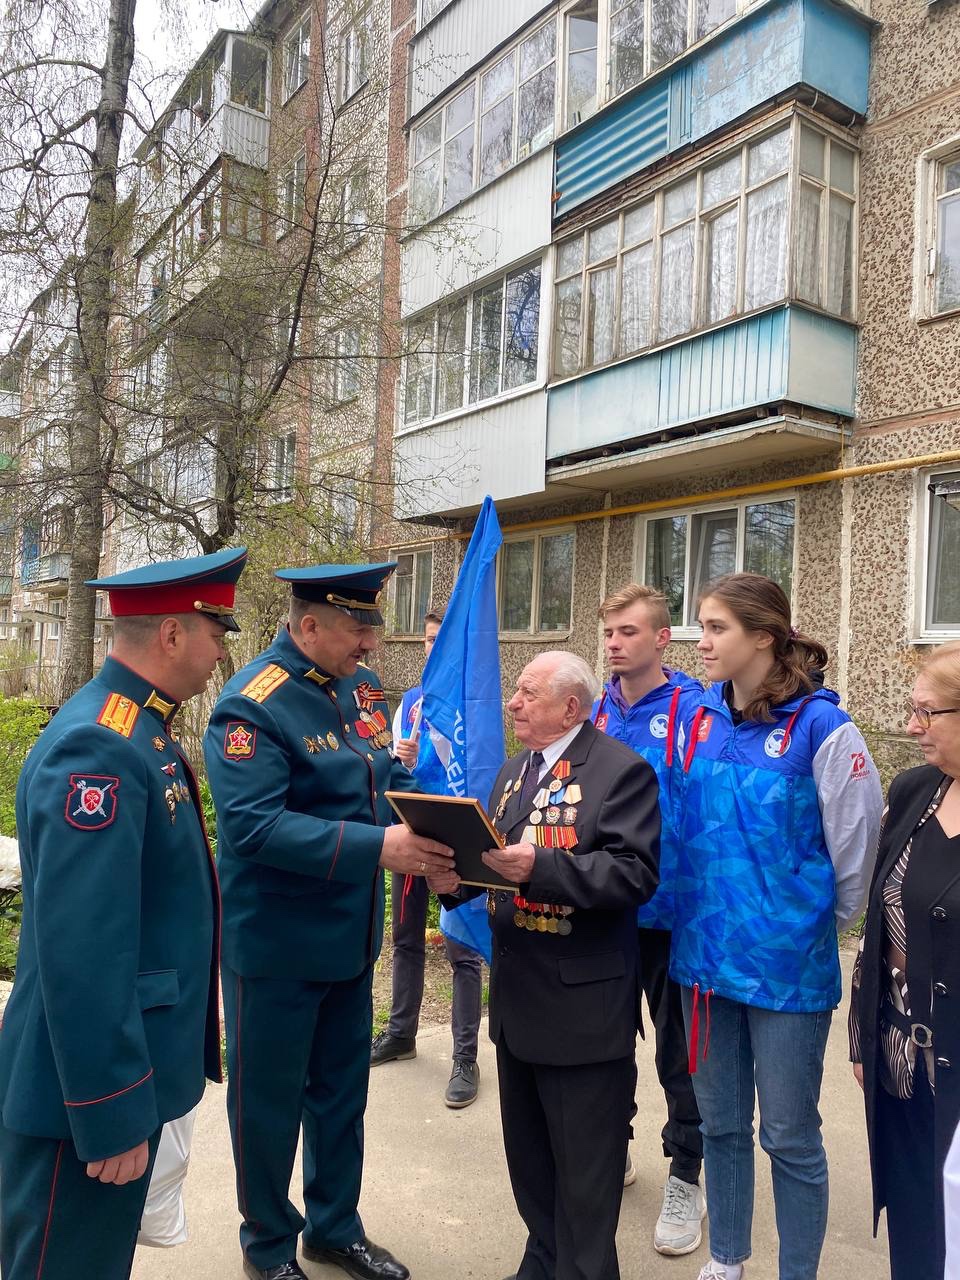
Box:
[671,684,883,1012]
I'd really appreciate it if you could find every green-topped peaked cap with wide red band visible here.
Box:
[86,547,247,631]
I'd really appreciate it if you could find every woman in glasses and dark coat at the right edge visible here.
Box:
[850,641,960,1280]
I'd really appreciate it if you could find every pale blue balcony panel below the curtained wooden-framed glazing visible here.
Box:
[547,306,856,463]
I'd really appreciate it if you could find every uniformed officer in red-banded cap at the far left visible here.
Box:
[0,548,246,1280]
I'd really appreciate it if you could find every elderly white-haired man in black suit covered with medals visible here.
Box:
[431,652,660,1280]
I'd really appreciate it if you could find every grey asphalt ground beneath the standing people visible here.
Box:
[133,952,890,1280]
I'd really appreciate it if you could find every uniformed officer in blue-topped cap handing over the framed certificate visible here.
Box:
[204,563,452,1280]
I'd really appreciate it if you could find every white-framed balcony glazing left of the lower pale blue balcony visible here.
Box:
[403,262,540,425]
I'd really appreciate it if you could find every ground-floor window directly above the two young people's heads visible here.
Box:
[647,498,796,628]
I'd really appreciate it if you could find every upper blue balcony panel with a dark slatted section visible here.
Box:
[554,0,872,218]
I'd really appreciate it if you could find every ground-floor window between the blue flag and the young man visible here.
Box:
[497,530,575,634]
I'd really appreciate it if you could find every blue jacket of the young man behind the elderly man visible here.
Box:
[591,667,703,929]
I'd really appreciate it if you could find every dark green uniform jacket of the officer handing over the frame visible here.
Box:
[204,630,416,982]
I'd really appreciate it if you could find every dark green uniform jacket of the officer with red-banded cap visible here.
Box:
[0,658,220,1167]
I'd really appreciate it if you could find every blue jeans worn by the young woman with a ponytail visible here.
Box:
[684,987,832,1280]
